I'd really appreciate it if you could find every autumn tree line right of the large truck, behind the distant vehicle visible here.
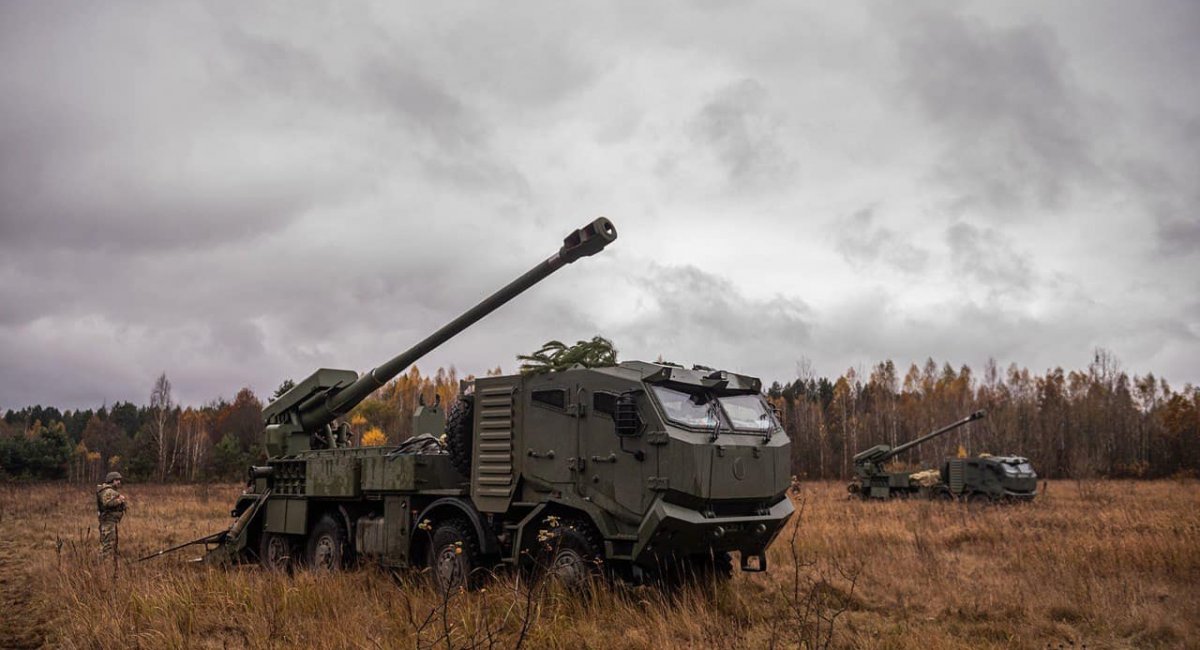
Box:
[768,349,1200,479]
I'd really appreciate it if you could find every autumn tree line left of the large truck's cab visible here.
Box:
[0,367,477,482]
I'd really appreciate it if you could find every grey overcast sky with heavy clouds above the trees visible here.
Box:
[0,0,1200,407]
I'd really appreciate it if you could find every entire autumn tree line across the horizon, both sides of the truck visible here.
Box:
[0,352,1200,482]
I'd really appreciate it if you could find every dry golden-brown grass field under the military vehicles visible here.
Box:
[0,481,1200,650]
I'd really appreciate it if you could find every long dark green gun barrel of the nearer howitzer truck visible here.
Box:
[284,217,617,431]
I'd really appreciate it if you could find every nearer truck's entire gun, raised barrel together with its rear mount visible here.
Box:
[263,217,617,457]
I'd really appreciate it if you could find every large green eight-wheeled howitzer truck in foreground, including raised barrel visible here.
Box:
[205,218,793,589]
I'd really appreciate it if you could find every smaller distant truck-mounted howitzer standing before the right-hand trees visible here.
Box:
[848,411,1038,502]
